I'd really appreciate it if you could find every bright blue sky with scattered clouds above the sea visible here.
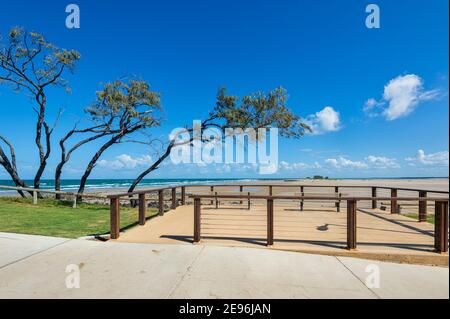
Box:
[0,0,449,178]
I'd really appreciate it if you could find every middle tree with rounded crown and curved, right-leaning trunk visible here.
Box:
[78,80,162,199]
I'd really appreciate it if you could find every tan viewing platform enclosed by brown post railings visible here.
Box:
[0,184,448,265]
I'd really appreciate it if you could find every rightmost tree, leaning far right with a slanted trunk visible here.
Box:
[128,87,311,192]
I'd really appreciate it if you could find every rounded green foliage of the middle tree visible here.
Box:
[85,80,162,130]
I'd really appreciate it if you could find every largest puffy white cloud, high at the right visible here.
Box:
[363,74,440,121]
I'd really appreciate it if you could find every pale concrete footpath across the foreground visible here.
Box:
[0,233,449,298]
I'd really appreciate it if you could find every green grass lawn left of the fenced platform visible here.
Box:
[0,197,157,238]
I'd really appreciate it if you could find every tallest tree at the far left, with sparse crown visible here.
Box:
[0,27,80,188]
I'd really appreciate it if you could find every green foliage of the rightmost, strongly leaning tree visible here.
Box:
[210,87,311,138]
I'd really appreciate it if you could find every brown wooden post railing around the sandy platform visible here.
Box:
[0,184,449,252]
